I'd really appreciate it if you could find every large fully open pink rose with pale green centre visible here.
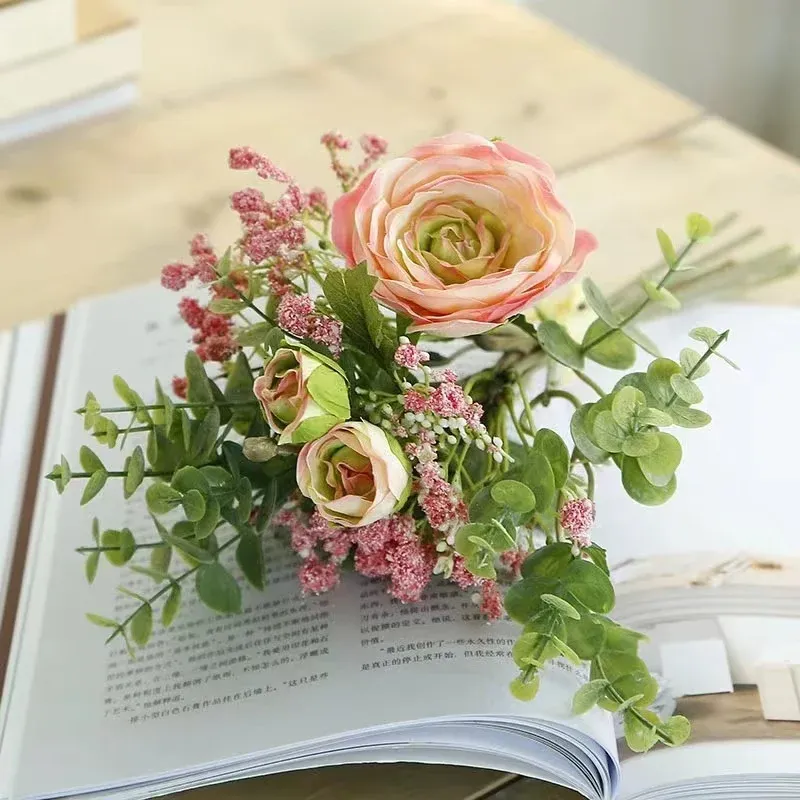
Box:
[332,133,597,337]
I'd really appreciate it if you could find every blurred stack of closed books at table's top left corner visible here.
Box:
[0,0,141,144]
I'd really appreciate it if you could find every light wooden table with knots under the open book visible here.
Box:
[0,0,800,800]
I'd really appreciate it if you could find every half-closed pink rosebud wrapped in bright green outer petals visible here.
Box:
[253,345,350,444]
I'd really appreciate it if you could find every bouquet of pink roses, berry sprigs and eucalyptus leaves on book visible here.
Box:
[48,133,727,750]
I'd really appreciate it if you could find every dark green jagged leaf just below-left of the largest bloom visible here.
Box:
[322,262,397,363]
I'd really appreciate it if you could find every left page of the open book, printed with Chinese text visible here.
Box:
[4,287,615,797]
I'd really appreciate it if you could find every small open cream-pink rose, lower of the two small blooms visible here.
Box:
[297,420,411,528]
